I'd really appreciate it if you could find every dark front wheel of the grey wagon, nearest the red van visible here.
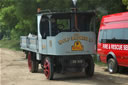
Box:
[85,56,94,78]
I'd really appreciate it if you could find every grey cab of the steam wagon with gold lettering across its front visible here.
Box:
[37,11,95,55]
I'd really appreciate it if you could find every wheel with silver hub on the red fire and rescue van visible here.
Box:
[108,58,118,73]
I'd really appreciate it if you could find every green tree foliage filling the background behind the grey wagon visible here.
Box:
[0,0,128,40]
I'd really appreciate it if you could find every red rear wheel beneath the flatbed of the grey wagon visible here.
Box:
[28,52,38,73]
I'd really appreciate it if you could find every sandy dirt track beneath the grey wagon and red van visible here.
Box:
[0,48,128,85]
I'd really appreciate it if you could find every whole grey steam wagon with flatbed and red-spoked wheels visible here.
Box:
[20,0,96,80]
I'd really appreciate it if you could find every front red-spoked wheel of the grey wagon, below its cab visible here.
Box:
[44,57,54,80]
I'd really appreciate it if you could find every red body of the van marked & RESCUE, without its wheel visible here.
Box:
[97,12,128,67]
